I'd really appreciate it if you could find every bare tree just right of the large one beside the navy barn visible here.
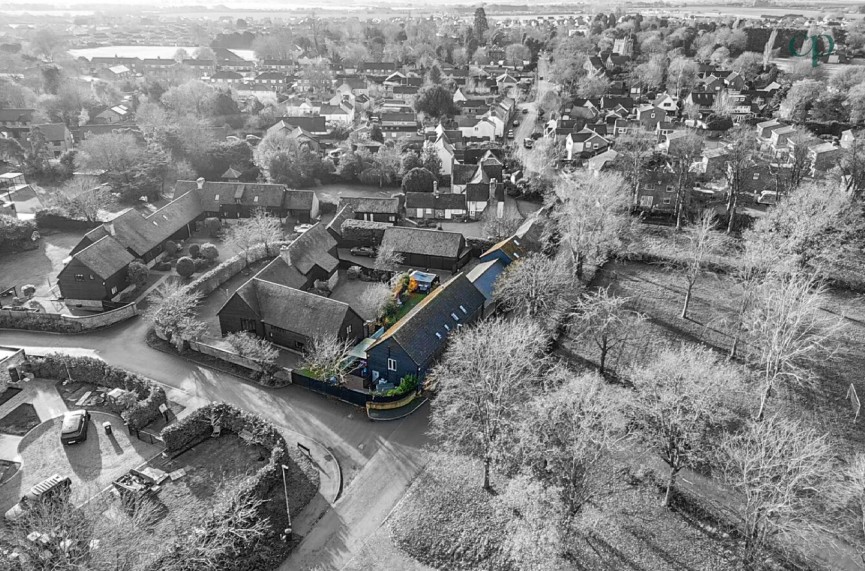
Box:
[517,369,629,517]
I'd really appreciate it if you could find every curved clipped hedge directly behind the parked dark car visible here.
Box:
[30,353,167,430]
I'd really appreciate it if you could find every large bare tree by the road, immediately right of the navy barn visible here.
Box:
[430,319,546,490]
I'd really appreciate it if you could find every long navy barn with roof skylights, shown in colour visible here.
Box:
[366,272,486,385]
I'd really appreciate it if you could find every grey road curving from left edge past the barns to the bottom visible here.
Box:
[0,317,429,570]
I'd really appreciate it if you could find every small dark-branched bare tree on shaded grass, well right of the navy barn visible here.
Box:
[571,287,644,375]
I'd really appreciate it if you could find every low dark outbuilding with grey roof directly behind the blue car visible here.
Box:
[381,226,470,272]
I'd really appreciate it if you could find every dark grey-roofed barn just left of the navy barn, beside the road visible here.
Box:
[217,277,364,352]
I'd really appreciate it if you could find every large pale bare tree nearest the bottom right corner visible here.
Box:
[719,415,832,571]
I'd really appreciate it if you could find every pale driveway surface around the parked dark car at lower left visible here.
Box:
[0,412,162,511]
